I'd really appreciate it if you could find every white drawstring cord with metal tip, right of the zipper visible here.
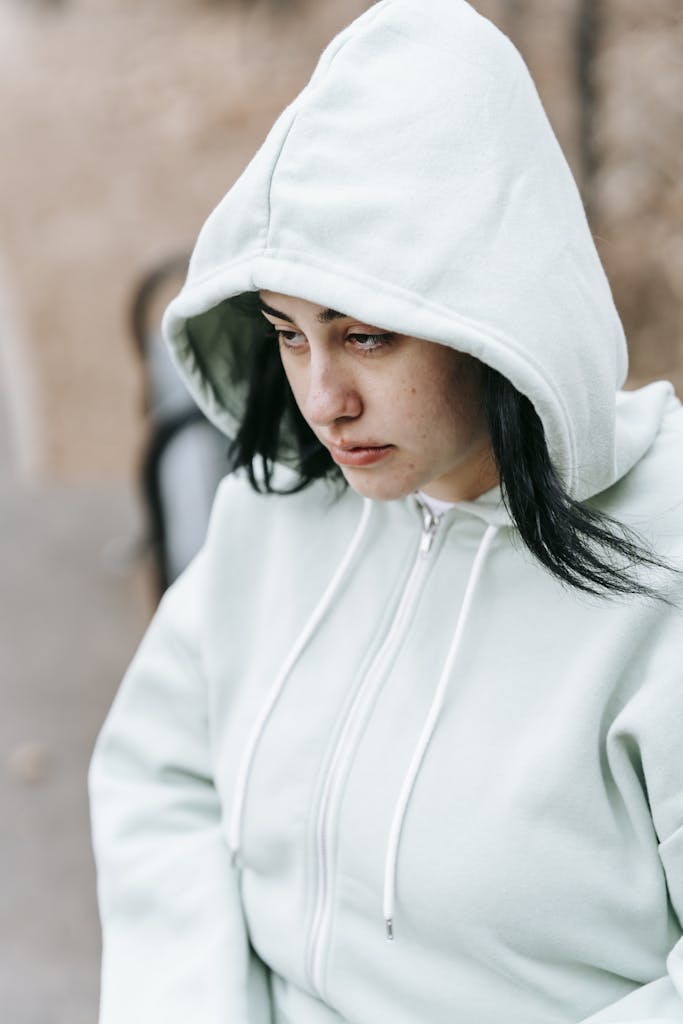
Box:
[383,526,498,941]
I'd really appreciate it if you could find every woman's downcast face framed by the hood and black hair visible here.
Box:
[260,291,498,501]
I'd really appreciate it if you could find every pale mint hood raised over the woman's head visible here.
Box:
[164,0,670,499]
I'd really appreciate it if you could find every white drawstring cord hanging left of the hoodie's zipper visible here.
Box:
[227,498,372,865]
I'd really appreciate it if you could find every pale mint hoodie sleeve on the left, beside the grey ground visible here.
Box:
[89,556,270,1024]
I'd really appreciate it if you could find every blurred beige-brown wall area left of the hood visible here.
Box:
[0,0,366,480]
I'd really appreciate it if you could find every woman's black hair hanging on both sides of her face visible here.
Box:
[230,334,664,598]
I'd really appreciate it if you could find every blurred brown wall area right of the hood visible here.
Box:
[475,0,683,395]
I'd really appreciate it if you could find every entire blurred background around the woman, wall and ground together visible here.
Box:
[0,0,683,1024]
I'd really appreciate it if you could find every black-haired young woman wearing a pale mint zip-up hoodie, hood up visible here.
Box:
[91,0,683,1024]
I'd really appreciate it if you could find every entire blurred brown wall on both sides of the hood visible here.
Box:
[0,0,683,479]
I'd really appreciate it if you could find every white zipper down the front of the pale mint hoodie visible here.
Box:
[306,498,442,996]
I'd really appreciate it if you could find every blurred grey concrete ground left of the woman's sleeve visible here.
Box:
[0,394,151,1024]
